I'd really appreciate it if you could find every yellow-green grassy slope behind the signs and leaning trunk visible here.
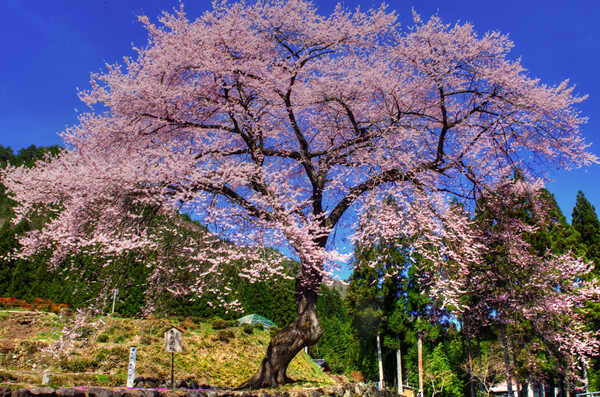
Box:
[0,313,332,387]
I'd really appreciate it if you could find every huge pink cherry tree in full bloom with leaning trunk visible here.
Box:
[3,0,596,388]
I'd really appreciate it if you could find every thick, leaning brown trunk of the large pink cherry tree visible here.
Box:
[238,273,323,389]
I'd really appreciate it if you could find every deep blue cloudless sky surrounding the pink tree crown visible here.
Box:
[0,0,600,221]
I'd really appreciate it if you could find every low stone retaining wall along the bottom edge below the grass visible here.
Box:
[0,383,399,397]
